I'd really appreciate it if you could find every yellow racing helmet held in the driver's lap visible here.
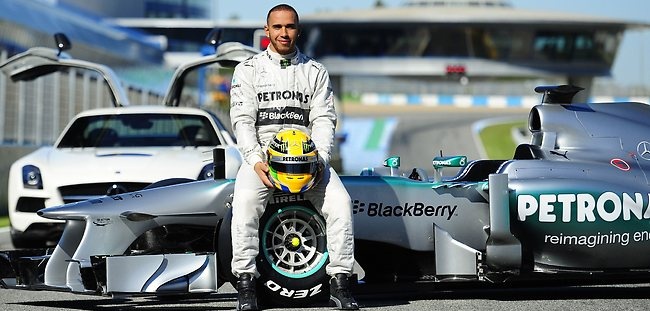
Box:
[267,129,318,193]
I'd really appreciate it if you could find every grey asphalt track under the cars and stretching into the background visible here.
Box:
[0,107,650,311]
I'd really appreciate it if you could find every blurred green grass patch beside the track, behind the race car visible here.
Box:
[479,121,526,159]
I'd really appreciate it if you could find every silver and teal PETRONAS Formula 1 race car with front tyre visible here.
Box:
[0,85,650,305]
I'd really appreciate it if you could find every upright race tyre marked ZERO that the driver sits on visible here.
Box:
[252,205,329,306]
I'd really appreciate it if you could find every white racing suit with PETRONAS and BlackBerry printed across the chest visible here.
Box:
[225,50,354,276]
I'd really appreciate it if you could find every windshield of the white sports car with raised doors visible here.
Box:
[57,113,220,148]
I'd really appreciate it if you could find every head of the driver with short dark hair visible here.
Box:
[264,10,300,54]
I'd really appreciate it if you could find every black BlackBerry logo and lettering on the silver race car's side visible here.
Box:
[352,200,458,220]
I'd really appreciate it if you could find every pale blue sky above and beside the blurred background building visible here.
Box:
[213,0,650,87]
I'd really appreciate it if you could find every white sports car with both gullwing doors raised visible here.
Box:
[0,33,256,248]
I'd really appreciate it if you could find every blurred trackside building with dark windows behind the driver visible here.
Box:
[93,0,648,105]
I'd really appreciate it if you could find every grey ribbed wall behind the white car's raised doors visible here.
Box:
[0,51,163,146]
